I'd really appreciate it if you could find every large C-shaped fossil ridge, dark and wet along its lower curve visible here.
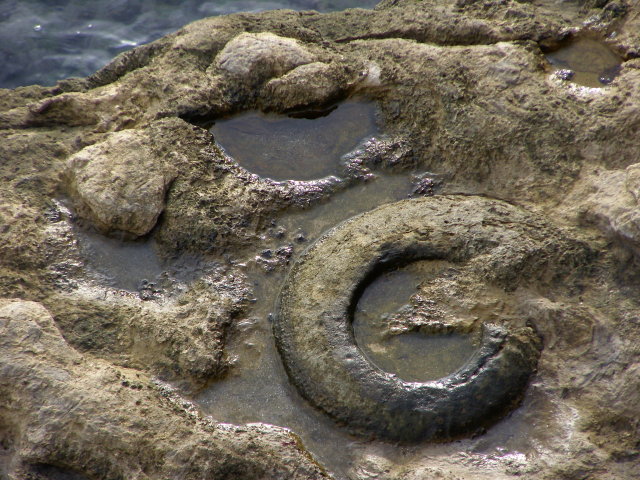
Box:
[274,195,576,442]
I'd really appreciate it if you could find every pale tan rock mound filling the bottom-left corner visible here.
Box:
[0,300,325,479]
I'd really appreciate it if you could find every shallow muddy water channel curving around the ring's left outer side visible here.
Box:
[194,175,412,478]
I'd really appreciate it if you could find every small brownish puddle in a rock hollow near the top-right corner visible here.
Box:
[546,38,622,88]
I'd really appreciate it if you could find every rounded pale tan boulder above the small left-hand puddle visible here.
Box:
[67,130,175,235]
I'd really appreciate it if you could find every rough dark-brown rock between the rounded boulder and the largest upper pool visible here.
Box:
[151,120,343,252]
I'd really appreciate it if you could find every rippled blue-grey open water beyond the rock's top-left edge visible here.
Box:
[0,0,379,88]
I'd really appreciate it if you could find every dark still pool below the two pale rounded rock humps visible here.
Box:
[211,101,378,180]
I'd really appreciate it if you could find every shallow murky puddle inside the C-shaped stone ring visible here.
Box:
[353,260,477,382]
